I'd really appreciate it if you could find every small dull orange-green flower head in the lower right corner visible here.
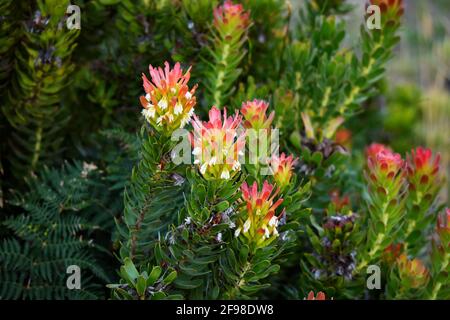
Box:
[397,254,429,289]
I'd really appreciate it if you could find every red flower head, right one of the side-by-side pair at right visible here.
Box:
[407,147,441,193]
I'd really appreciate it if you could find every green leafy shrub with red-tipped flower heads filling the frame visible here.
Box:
[0,0,450,300]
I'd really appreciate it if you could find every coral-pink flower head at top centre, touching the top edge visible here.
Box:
[214,0,250,37]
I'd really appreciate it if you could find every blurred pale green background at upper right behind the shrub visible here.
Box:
[348,0,450,203]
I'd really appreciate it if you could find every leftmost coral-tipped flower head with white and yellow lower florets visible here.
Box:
[140,62,197,134]
